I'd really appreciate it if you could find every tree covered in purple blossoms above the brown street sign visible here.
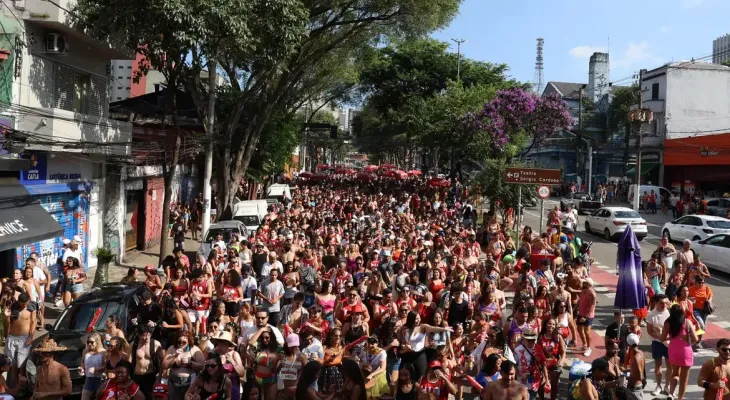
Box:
[463,88,573,155]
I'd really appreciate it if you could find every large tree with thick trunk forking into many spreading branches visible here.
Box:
[186,0,461,213]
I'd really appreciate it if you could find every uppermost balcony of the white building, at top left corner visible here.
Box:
[8,0,135,60]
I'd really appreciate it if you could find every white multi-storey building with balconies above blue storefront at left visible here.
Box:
[0,0,134,278]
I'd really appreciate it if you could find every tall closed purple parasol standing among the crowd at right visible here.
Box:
[613,225,647,310]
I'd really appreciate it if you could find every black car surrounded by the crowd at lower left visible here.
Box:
[26,283,146,396]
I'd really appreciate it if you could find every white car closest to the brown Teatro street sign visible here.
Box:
[585,207,649,240]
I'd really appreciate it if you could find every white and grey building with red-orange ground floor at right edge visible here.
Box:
[637,61,730,191]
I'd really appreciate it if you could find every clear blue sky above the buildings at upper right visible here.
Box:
[433,0,730,85]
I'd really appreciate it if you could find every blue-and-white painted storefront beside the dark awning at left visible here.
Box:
[16,152,95,279]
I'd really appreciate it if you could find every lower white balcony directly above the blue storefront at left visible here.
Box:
[17,108,132,156]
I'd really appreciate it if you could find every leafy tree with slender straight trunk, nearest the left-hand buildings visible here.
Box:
[71,0,250,263]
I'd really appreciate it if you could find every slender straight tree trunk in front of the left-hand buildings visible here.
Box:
[158,84,179,265]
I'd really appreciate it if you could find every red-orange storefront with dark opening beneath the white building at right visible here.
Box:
[663,133,730,193]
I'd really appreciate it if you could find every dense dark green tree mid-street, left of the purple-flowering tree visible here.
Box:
[353,39,517,165]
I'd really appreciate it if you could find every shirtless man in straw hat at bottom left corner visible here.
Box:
[32,339,71,400]
